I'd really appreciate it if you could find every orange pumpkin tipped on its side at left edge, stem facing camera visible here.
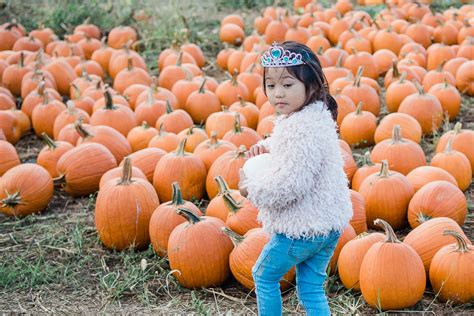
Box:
[0,163,54,216]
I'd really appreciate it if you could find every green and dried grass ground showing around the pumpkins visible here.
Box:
[0,0,474,315]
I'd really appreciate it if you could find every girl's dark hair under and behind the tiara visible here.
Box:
[263,41,337,121]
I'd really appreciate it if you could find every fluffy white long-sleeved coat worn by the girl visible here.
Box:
[245,102,352,238]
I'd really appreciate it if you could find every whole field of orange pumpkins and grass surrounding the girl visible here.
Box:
[0,0,474,315]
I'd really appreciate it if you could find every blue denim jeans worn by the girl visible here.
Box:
[252,231,341,316]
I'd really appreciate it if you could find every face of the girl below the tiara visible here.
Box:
[265,67,306,114]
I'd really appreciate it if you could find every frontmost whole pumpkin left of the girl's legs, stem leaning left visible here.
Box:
[168,207,233,288]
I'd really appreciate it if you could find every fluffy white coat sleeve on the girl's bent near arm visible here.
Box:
[246,102,330,210]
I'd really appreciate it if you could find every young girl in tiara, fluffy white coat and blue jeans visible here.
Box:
[239,42,352,315]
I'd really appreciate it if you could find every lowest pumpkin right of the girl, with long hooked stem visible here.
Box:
[359,219,426,310]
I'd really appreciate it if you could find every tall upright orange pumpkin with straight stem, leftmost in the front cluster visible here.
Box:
[95,159,160,250]
